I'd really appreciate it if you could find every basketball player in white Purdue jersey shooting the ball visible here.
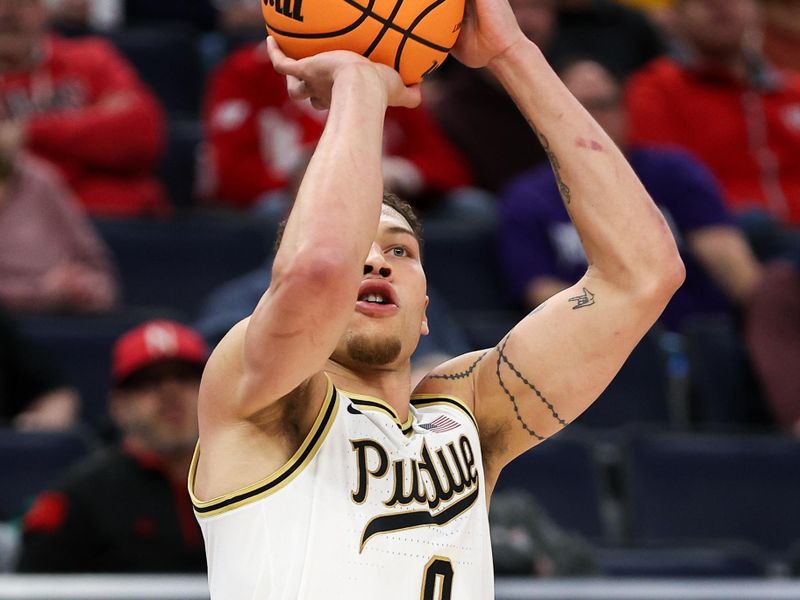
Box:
[190,0,683,600]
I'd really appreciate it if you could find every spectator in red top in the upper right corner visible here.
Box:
[628,0,800,226]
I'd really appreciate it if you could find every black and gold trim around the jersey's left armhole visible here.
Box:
[189,378,339,518]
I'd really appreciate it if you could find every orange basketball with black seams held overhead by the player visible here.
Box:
[262,0,464,84]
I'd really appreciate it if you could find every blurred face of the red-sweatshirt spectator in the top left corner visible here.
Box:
[0,0,47,62]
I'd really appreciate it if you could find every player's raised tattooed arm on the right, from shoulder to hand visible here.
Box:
[416,0,684,481]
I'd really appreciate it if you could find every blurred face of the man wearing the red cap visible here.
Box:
[111,362,200,453]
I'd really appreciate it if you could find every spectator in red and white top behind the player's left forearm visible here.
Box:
[204,43,470,208]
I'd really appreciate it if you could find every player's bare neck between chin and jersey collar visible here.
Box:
[325,360,411,420]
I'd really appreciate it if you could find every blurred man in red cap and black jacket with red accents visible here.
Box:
[17,321,208,573]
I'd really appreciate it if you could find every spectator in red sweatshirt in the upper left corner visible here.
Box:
[0,0,167,217]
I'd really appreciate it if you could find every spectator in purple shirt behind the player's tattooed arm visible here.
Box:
[500,59,761,331]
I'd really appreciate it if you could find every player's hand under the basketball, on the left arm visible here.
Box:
[267,37,422,110]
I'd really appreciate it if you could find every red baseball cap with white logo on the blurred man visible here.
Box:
[111,320,208,383]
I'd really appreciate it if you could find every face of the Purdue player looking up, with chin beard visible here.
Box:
[332,205,428,367]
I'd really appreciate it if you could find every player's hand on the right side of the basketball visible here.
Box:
[451,0,530,68]
